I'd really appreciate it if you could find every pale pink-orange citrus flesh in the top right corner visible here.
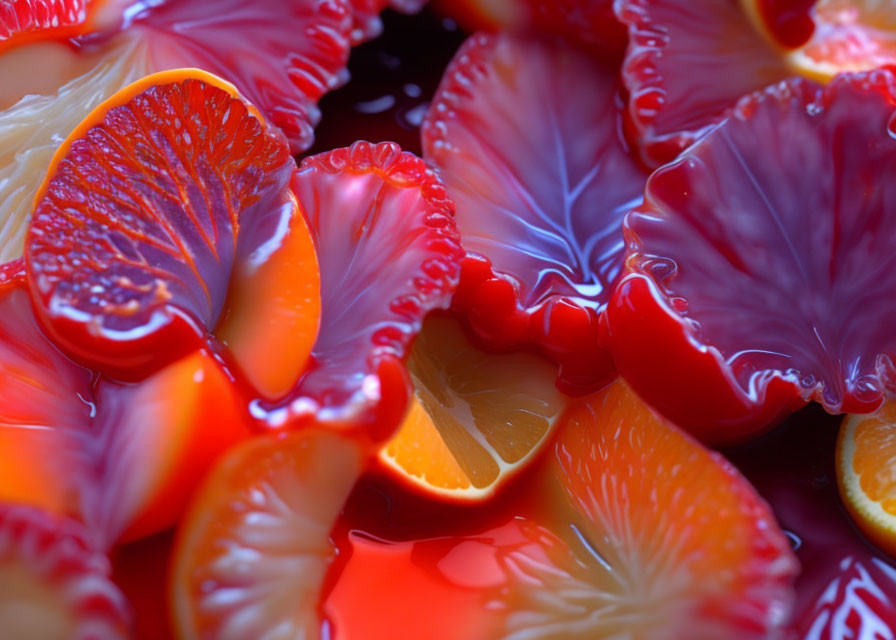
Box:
[788,0,896,81]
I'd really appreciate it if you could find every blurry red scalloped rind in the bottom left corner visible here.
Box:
[0,504,130,640]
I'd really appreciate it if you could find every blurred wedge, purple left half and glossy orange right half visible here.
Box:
[92,351,252,544]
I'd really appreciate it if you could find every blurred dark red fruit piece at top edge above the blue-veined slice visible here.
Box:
[434,0,626,55]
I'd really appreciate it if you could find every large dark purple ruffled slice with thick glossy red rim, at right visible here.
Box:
[607,71,896,443]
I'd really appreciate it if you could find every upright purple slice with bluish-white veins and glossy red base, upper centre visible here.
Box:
[422,34,646,391]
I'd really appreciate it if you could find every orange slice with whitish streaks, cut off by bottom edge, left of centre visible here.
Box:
[170,428,362,640]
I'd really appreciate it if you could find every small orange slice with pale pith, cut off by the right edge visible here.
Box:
[837,400,896,555]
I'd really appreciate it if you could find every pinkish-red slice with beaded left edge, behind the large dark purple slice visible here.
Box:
[616,0,792,167]
